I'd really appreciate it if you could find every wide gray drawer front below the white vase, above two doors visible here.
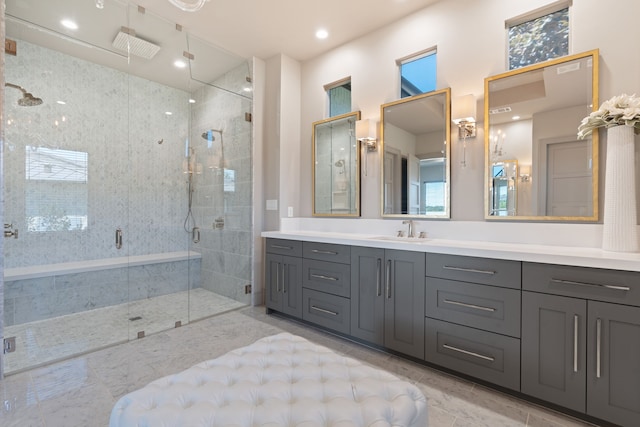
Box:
[522,262,640,306]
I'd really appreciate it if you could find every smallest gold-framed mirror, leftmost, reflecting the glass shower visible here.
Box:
[313,111,360,216]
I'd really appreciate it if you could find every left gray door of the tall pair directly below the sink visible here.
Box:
[351,246,384,345]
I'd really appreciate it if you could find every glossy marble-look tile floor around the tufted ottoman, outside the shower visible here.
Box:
[0,307,590,427]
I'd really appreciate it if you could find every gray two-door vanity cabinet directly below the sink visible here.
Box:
[351,246,425,359]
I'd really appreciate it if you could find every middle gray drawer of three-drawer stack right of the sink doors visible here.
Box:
[426,277,520,338]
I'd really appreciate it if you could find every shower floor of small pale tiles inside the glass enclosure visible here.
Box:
[4,288,245,373]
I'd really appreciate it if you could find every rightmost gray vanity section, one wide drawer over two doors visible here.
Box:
[522,263,640,426]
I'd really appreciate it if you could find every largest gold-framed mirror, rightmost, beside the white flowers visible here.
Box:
[485,50,598,221]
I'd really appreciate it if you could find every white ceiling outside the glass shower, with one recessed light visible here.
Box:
[132,0,439,61]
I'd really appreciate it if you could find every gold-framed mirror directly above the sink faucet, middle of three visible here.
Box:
[381,88,451,218]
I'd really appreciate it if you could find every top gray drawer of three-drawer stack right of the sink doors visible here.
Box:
[426,254,521,289]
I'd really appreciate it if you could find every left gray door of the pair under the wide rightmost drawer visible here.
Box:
[521,291,587,412]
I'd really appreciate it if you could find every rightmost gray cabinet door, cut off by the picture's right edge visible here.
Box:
[587,301,640,426]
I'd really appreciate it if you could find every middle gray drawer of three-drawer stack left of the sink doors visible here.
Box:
[302,258,351,298]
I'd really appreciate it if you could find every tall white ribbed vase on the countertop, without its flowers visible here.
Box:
[602,126,639,252]
